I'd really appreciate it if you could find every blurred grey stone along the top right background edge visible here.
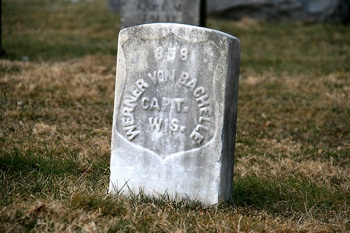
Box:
[207,0,350,22]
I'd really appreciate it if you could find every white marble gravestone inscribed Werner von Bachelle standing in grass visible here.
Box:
[109,23,240,205]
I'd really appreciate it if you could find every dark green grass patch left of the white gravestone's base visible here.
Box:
[0,148,107,206]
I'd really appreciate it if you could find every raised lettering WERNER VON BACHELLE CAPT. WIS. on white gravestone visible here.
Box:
[121,70,213,144]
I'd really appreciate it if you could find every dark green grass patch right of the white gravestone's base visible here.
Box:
[233,176,350,221]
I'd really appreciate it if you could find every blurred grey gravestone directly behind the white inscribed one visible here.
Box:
[120,0,206,28]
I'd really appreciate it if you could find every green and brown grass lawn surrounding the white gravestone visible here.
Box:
[0,0,350,232]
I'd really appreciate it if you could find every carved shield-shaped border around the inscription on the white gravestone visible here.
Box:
[113,27,226,159]
